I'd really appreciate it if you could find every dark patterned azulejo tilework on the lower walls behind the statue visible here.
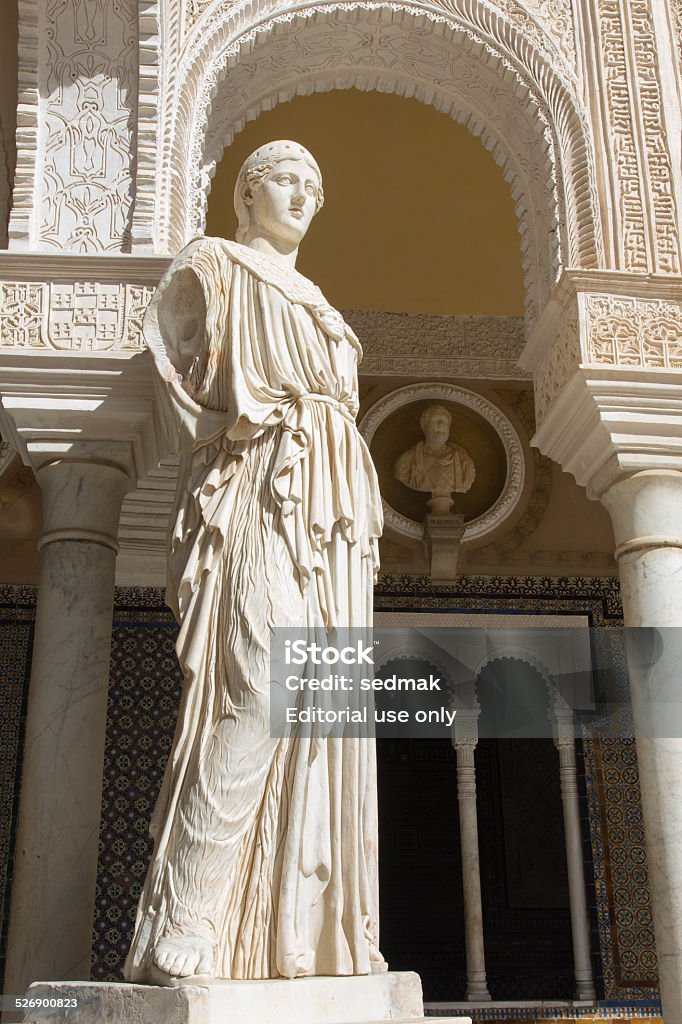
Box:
[0,575,656,999]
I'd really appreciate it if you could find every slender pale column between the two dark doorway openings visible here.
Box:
[453,708,491,1001]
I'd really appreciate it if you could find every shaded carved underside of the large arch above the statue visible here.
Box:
[193,13,565,319]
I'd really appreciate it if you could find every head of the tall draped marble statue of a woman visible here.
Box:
[235,140,325,246]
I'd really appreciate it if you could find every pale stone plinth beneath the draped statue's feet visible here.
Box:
[18,972,471,1024]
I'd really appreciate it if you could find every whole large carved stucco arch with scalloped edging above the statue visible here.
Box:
[133,0,602,323]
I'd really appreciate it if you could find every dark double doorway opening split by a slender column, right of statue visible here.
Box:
[377,659,593,1001]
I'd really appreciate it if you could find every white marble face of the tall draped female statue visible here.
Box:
[246,160,321,246]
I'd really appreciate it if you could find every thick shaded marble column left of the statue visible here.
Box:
[5,461,130,994]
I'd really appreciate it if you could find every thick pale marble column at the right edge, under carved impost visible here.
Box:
[600,469,682,1022]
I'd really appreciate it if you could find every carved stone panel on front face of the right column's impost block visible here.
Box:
[586,295,682,370]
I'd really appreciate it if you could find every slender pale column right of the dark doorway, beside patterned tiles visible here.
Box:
[554,709,597,1000]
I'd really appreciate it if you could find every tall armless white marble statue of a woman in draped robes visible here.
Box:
[125,142,385,983]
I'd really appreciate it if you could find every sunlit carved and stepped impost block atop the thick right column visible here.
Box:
[520,270,682,499]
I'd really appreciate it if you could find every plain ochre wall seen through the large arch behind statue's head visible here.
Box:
[207,89,523,316]
